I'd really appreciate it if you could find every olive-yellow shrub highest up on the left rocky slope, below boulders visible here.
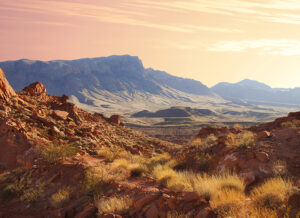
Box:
[39,144,79,164]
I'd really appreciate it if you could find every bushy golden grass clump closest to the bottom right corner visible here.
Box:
[251,177,294,209]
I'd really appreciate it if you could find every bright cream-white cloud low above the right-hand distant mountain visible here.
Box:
[207,39,300,56]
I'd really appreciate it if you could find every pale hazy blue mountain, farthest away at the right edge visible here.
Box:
[211,79,300,105]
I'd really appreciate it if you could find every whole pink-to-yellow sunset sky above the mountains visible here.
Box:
[0,0,300,88]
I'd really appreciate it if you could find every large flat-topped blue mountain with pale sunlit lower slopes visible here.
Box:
[0,55,217,113]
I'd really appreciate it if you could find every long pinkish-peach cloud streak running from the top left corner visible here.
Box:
[0,0,242,33]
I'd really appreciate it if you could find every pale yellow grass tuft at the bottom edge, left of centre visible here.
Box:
[96,196,133,215]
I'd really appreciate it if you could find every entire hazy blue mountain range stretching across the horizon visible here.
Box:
[0,55,300,125]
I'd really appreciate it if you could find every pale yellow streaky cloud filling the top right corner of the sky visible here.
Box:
[131,0,300,24]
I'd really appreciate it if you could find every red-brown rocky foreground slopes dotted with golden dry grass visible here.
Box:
[0,67,300,218]
